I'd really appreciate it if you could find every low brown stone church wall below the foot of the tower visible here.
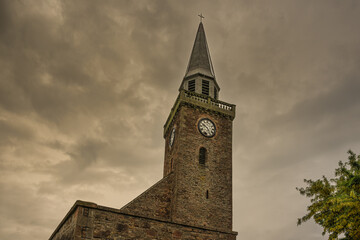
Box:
[50,201,237,240]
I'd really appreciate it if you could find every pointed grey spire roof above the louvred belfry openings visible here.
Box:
[185,22,215,79]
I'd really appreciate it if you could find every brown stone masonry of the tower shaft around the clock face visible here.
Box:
[165,105,232,231]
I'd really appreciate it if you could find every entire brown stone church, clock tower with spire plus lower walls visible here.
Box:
[50,22,237,240]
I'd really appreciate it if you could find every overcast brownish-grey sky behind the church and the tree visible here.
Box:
[0,0,360,240]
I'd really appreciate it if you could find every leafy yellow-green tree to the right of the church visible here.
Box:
[296,150,360,240]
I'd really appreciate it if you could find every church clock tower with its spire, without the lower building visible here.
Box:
[164,22,235,231]
